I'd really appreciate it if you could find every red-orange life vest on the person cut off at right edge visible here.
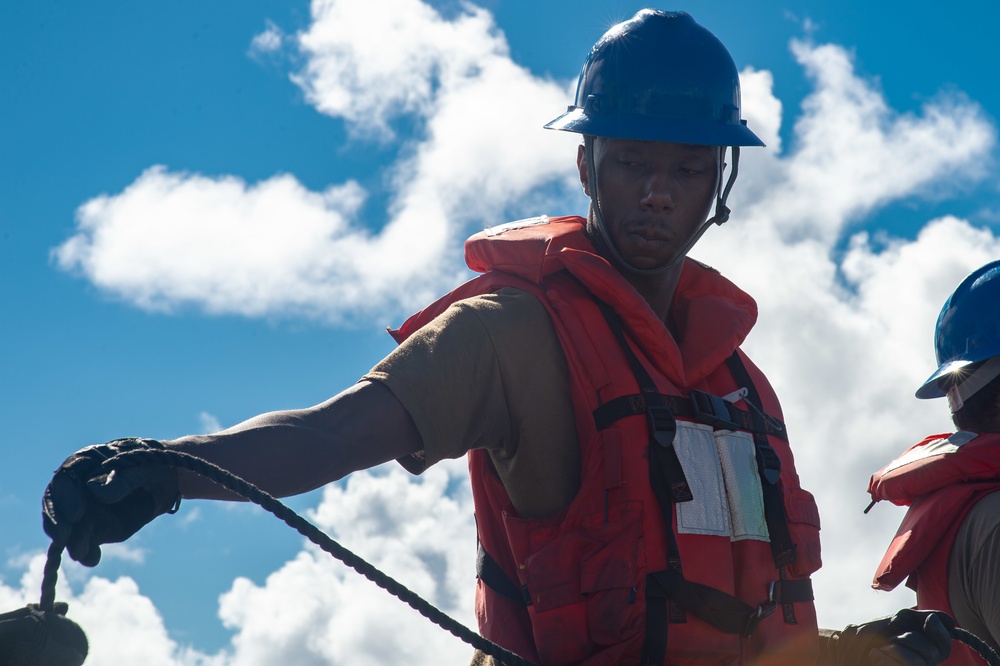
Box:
[868,432,1000,666]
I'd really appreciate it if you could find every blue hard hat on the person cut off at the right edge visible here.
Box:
[917,260,1000,398]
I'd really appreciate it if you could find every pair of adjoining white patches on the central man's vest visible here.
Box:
[674,421,770,541]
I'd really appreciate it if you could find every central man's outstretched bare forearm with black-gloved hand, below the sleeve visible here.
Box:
[42,382,421,566]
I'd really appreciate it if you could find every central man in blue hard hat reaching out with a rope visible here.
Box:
[44,10,950,666]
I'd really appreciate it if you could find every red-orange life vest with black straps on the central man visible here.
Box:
[392,217,820,666]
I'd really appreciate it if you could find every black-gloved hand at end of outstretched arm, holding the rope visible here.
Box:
[42,438,180,567]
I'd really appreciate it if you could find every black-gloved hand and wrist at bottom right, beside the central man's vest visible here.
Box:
[828,608,955,666]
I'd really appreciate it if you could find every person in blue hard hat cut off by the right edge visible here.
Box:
[869,261,1000,666]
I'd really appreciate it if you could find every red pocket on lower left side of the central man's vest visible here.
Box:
[506,502,642,665]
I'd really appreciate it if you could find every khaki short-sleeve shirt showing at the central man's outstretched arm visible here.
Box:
[363,288,580,518]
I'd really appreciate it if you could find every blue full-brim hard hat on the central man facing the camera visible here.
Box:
[545,9,764,146]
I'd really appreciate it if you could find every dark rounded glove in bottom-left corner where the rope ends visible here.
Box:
[0,603,88,666]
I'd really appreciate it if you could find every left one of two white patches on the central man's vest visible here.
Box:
[674,421,732,536]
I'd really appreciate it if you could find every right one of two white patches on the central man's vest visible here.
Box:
[715,430,770,541]
